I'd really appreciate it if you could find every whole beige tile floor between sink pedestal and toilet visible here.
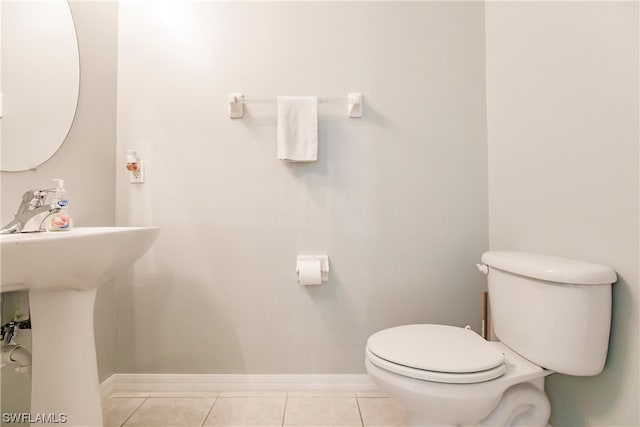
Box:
[102,391,407,427]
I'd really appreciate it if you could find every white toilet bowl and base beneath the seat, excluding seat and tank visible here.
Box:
[365,343,552,427]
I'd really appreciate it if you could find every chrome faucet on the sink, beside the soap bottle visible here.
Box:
[0,188,60,234]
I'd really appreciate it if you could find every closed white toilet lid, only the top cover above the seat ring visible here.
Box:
[367,324,504,374]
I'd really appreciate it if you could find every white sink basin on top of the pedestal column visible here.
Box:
[0,227,158,292]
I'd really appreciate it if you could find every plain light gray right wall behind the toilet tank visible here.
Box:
[486,2,640,427]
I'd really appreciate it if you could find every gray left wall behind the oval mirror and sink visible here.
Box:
[1,1,118,380]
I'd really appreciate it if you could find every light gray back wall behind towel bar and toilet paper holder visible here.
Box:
[116,2,488,374]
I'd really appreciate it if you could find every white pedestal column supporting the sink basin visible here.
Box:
[29,288,102,427]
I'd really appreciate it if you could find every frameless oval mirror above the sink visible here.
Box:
[0,0,80,172]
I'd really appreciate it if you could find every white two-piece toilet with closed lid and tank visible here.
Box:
[365,251,617,427]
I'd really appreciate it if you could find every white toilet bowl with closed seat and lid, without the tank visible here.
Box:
[365,324,552,427]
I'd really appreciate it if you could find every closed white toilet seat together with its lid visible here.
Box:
[366,324,506,384]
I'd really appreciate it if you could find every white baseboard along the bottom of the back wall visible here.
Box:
[100,374,376,396]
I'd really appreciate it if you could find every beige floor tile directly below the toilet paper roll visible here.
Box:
[284,397,362,427]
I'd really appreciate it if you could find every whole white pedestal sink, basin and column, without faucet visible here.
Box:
[0,231,158,427]
